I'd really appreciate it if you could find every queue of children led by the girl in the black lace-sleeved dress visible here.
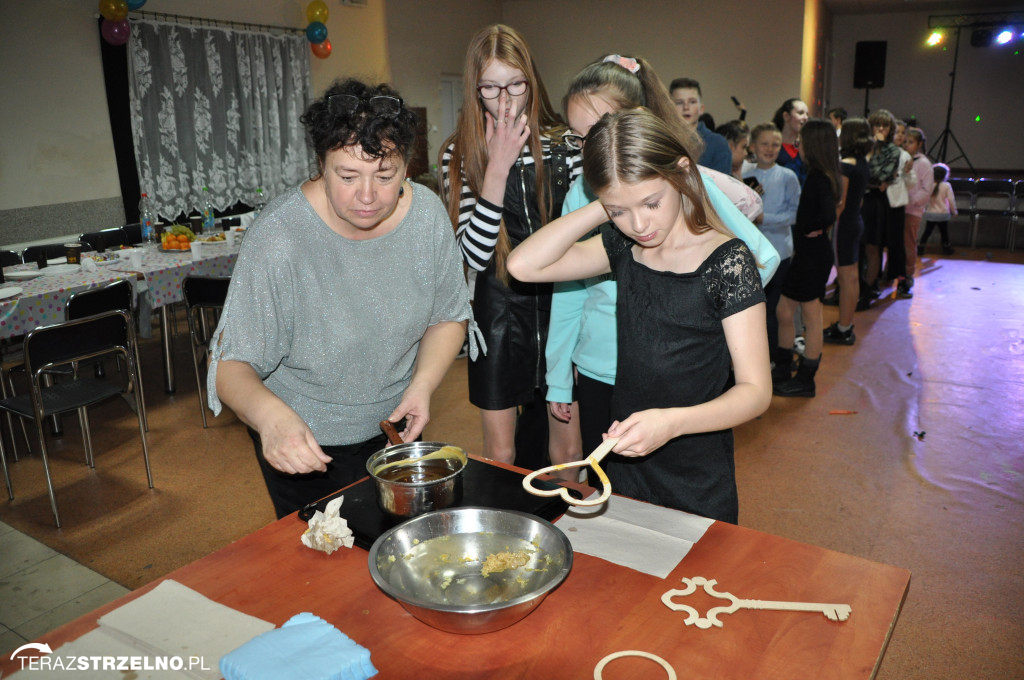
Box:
[430,25,942,521]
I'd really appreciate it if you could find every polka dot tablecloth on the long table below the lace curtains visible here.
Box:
[0,244,239,338]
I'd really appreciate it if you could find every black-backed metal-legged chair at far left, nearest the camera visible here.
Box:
[0,310,153,528]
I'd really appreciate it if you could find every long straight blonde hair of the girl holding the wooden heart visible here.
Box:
[583,109,734,241]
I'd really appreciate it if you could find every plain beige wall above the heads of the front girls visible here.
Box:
[503,0,804,133]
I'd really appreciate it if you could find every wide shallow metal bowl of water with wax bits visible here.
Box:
[370,507,572,633]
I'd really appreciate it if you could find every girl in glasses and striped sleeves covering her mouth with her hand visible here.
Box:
[440,25,582,467]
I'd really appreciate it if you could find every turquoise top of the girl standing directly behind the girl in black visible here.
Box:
[545,174,780,403]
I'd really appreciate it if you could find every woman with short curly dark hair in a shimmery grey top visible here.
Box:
[209,80,470,517]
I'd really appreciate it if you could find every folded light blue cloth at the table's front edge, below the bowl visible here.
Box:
[220,612,377,680]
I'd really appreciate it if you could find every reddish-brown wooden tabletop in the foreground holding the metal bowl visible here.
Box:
[0,462,910,680]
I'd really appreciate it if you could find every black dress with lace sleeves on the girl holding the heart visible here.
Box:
[603,229,765,523]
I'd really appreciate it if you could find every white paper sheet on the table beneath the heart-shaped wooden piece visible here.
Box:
[555,492,715,579]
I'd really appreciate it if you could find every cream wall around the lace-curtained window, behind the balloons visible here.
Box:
[0,0,390,243]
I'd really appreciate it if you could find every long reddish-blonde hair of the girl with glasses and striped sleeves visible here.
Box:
[440,24,567,282]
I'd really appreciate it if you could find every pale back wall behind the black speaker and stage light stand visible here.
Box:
[828,4,1024,171]
